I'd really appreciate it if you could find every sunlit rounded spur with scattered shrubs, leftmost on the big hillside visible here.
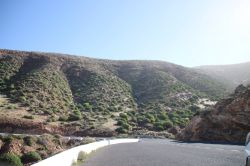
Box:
[10,64,73,114]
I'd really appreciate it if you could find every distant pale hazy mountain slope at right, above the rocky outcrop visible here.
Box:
[195,62,250,91]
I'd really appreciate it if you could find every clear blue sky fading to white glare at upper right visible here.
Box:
[0,0,250,66]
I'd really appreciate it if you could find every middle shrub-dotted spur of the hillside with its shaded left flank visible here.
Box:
[65,65,135,112]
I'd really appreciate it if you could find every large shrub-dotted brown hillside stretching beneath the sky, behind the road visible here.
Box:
[0,50,226,136]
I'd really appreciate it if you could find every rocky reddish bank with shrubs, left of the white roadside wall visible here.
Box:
[0,134,94,166]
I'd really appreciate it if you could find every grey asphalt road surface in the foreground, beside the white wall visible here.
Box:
[83,139,245,166]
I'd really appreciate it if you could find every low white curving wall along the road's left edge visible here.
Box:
[32,139,139,166]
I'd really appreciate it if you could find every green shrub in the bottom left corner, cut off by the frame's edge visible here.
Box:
[0,152,23,166]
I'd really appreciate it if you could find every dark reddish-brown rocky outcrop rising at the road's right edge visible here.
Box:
[177,85,250,143]
